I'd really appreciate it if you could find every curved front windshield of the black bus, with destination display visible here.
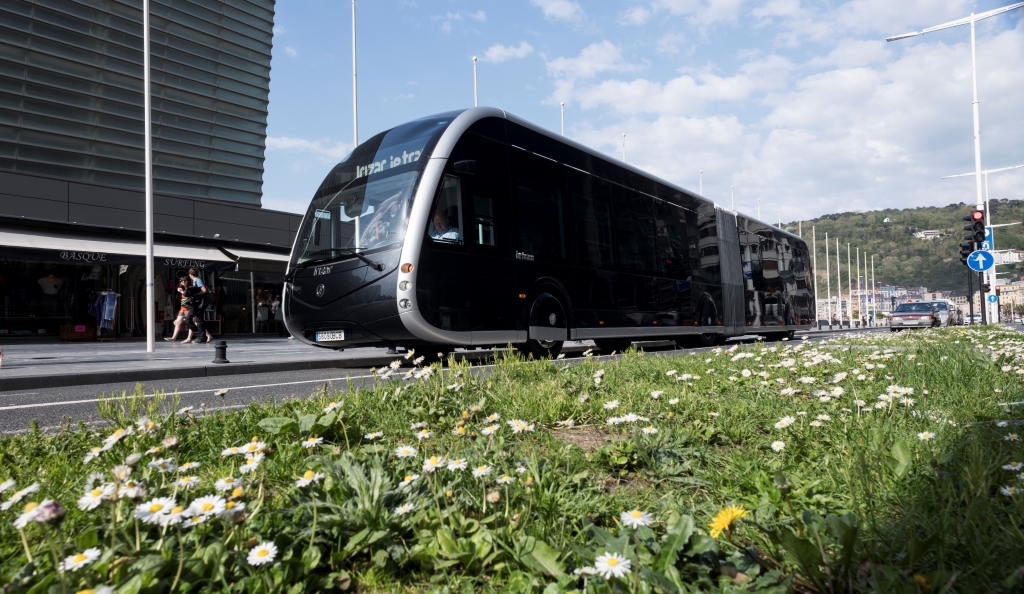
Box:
[292,113,458,266]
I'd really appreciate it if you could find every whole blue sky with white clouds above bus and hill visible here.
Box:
[263,0,1024,222]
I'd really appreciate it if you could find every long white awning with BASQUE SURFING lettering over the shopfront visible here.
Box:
[0,226,237,270]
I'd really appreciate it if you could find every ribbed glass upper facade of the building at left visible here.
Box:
[0,0,274,206]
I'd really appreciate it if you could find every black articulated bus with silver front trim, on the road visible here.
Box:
[284,108,814,356]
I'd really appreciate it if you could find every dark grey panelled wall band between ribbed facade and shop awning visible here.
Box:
[0,171,302,248]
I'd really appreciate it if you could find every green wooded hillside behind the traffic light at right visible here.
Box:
[784,200,1024,291]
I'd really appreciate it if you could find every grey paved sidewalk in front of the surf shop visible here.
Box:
[0,338,670,392]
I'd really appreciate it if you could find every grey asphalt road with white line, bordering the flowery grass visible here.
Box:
[0,329,888,434]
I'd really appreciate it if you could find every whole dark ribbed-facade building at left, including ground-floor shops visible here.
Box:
[0,0,301,339]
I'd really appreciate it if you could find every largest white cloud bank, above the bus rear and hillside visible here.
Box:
[549,22,1024,221]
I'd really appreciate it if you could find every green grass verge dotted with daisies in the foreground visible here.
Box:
[0,329,1024,592]
